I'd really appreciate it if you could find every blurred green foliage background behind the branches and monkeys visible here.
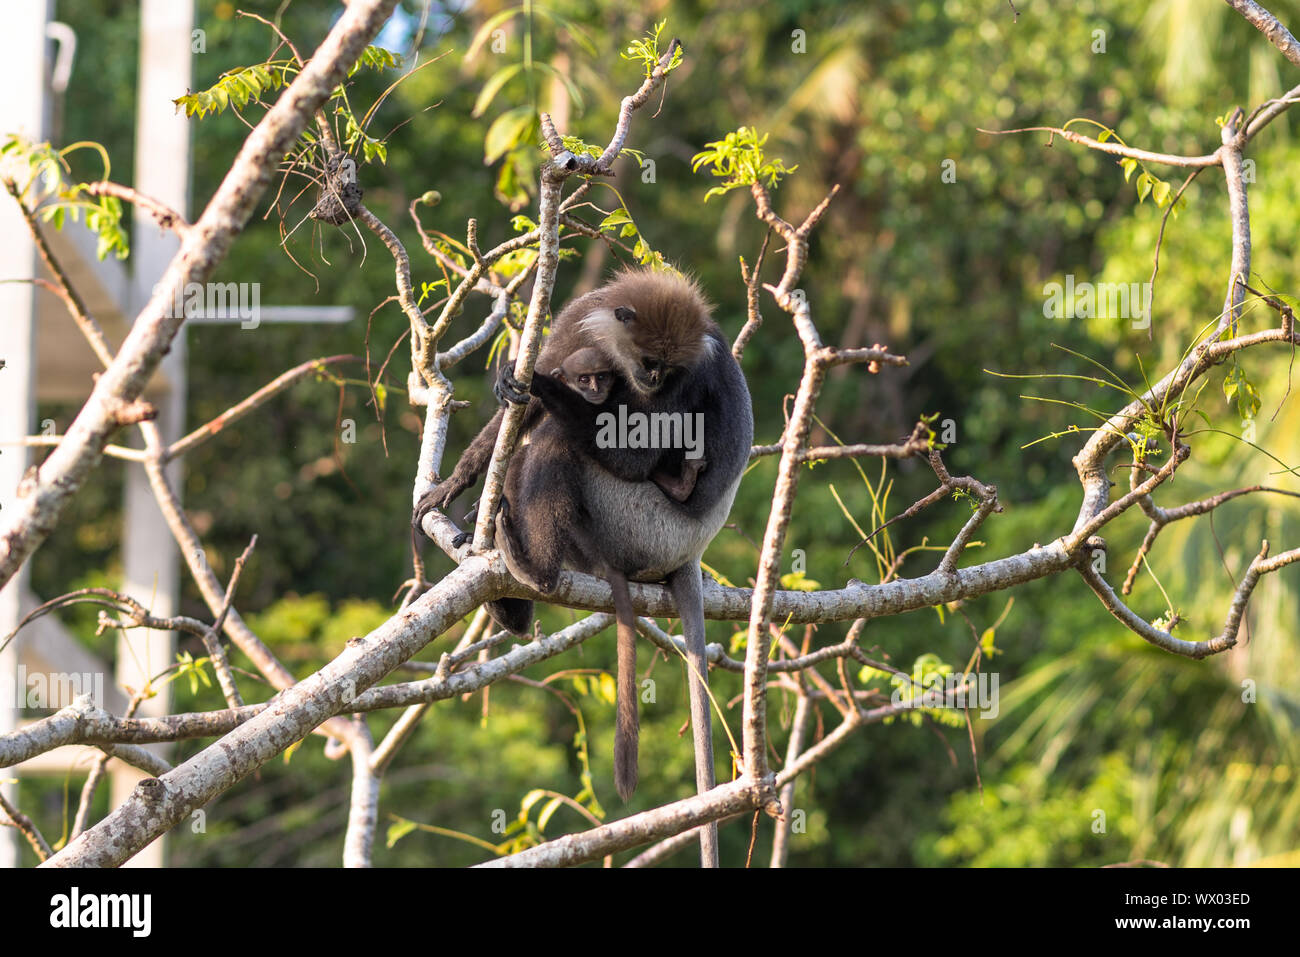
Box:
[17,0,1300,866]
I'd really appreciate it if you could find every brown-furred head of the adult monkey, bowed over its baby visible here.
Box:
[581,269,718,395]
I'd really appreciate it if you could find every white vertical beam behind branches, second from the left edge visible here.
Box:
[112,0,194,867]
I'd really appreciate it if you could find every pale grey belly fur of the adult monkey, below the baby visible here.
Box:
[582,463,741,581]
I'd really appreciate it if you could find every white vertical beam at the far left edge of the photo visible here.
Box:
[0,0,52,867]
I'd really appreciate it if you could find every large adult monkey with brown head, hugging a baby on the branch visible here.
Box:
[416,270,754,866]
